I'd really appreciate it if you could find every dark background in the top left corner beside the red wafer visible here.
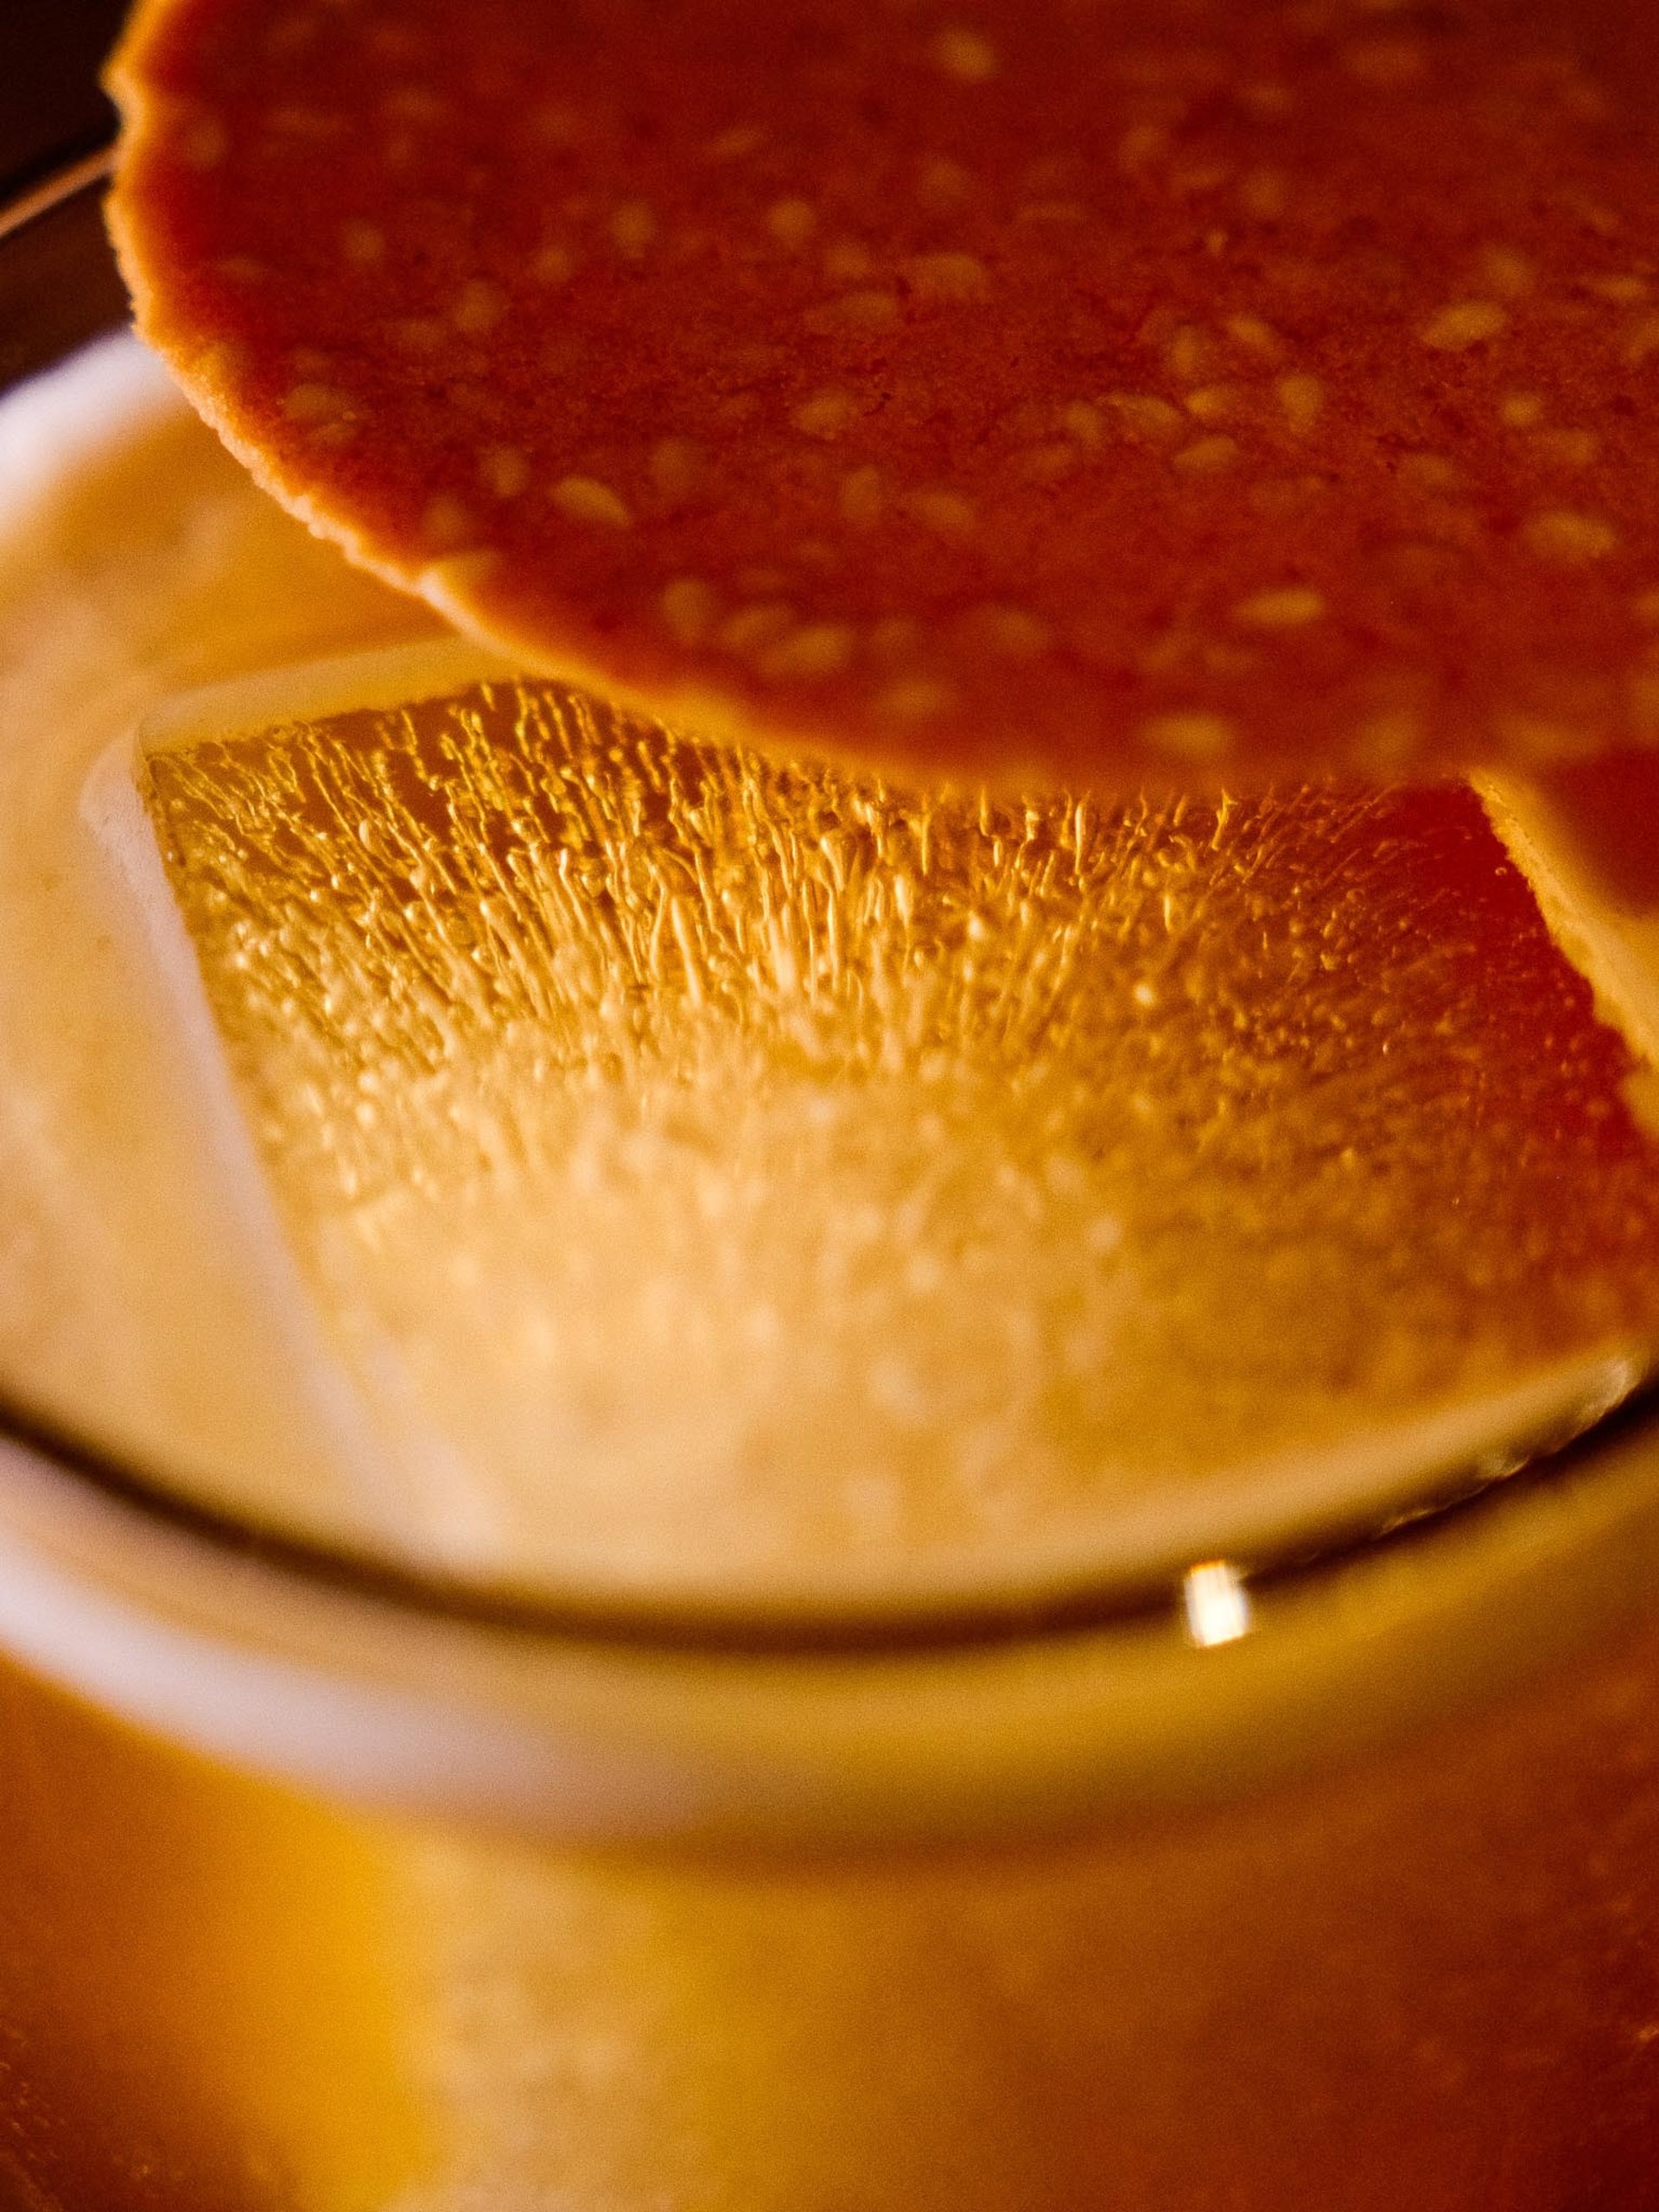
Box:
[0,0,126,204]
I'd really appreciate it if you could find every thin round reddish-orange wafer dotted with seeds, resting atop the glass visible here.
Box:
[104,0,1659,787]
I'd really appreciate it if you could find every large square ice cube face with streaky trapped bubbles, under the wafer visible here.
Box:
[133,683,1659,1601]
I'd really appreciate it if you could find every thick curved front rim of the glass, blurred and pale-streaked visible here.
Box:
[0,1380,1659,1852]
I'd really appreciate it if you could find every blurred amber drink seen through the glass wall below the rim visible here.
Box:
[0,1592,1659,2212]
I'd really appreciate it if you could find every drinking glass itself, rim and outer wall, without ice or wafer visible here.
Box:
[0,156,1659,2212]
